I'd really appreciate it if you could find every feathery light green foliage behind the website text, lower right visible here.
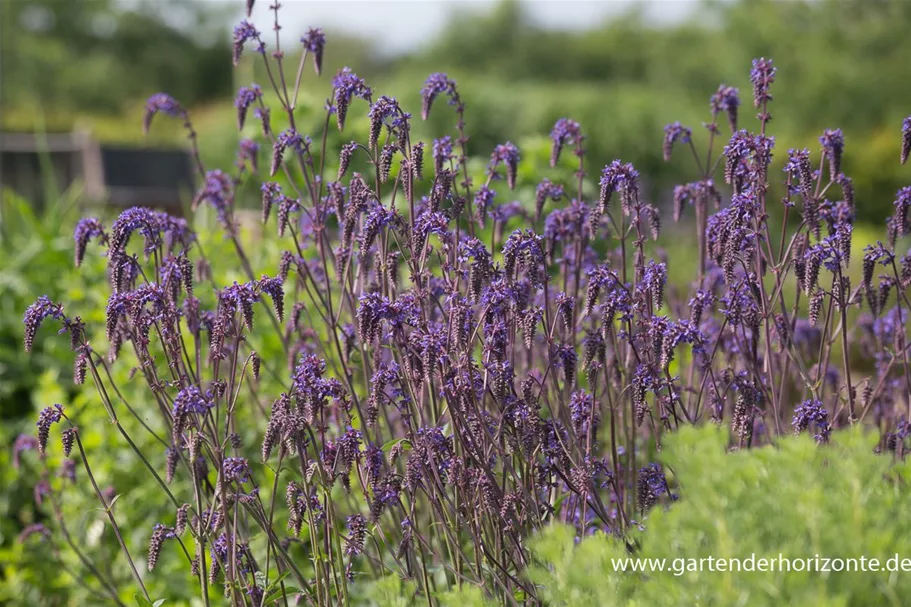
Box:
[529,428,911,607]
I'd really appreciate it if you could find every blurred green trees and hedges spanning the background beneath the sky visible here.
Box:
[0,0,911,221]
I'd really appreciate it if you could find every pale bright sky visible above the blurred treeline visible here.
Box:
[236,0,696,54]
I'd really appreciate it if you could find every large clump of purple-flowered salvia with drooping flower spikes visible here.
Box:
[16,3,911,606]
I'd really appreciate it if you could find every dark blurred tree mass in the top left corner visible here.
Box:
[0,0,232,113]
